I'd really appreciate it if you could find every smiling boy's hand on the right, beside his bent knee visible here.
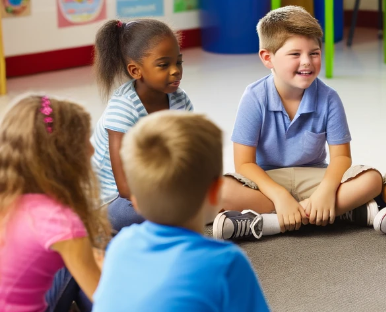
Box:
[305,188,336,226]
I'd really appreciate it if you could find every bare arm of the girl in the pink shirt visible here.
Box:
[51,237,101,301]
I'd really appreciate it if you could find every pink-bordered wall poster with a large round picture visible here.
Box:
[56,0,106,28]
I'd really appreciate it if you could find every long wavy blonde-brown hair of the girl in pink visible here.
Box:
[0,96,110,247]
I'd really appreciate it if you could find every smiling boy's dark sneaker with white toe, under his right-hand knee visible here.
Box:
[339,199,379,226]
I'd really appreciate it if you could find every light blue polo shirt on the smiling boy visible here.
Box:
[232,75,351,170]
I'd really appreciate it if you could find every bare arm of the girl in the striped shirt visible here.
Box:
[107,130,130,199]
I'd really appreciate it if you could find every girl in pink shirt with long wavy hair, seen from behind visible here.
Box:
[0,96,110,312]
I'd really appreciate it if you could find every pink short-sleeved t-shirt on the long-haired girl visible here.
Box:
[0,194,87,312]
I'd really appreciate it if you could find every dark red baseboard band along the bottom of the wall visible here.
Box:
[5,28,201,77]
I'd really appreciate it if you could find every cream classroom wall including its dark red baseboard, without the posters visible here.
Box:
[2,0,378,77]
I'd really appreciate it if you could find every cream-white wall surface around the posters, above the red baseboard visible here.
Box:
[3,0,199,56]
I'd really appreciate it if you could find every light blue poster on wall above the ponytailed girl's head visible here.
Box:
[117,0,164,17]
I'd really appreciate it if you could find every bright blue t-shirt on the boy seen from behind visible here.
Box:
[93,221,269,312]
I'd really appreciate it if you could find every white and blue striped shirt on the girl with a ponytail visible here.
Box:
[91,80,193,204]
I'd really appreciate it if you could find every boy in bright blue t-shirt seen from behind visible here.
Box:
[93,111,269,312]
